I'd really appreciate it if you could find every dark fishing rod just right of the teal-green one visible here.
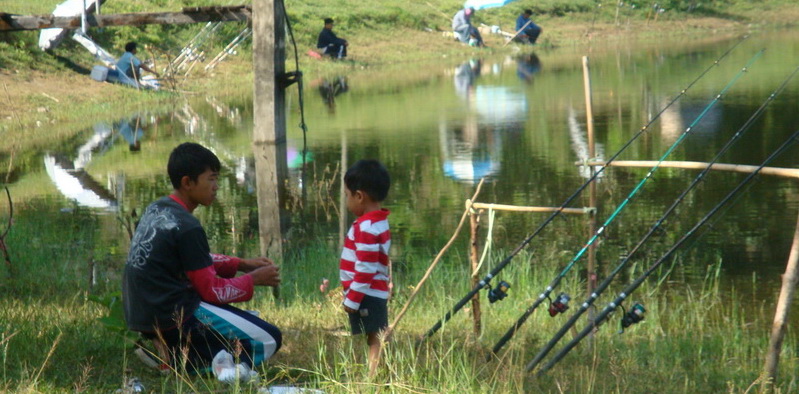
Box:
[526,63,799,371]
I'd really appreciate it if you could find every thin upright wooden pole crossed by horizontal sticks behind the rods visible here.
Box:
[583,56,597,332]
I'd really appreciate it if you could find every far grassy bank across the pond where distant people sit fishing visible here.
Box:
[0,0,799,137]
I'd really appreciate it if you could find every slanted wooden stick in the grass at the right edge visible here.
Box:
[763,208,799,385]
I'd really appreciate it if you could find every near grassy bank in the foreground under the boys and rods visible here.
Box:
[0,202,799,393]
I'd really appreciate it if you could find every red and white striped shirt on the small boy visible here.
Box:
[339,209,391,310]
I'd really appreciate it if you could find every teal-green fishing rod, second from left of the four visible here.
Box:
[488,49,765,358]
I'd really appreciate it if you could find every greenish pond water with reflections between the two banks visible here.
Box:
[3,32,799,310]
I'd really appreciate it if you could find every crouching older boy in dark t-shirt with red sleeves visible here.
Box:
[122,142,282,380]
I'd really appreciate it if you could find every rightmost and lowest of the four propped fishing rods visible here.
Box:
[527,131,799,376]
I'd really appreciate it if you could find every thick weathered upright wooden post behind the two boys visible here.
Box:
[253,0,288,274]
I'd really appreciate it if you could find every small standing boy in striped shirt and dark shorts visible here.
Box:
[339,160,391,375]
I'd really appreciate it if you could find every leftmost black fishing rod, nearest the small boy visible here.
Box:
[420,35,749,342]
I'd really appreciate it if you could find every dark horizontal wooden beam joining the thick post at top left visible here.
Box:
[0,6,252,31]
